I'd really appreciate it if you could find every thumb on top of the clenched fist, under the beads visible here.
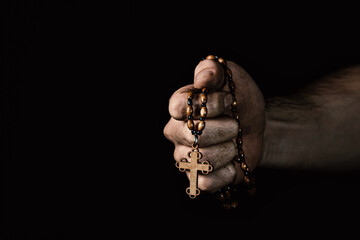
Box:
[194,59,224,90]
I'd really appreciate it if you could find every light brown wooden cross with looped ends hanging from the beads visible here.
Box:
[175,149,213,199]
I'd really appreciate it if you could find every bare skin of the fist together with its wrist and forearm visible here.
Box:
[164,60,360,192]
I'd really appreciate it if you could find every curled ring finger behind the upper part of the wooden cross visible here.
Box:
[174,141,236,170]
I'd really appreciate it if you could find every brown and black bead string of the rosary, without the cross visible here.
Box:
[197,55,256,210]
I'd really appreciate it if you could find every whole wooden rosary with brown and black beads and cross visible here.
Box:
[175,55,256,210]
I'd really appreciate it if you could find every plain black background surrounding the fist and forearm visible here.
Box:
[2,1,360,239]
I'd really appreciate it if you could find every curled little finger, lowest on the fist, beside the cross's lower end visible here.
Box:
[186,162,236,193]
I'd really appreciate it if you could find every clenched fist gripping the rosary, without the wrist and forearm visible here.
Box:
[164,60,265,192]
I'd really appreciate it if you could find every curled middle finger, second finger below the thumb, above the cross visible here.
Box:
[164,116,238,147]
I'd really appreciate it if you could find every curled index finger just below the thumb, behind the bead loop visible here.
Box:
[169,85,232,120]
